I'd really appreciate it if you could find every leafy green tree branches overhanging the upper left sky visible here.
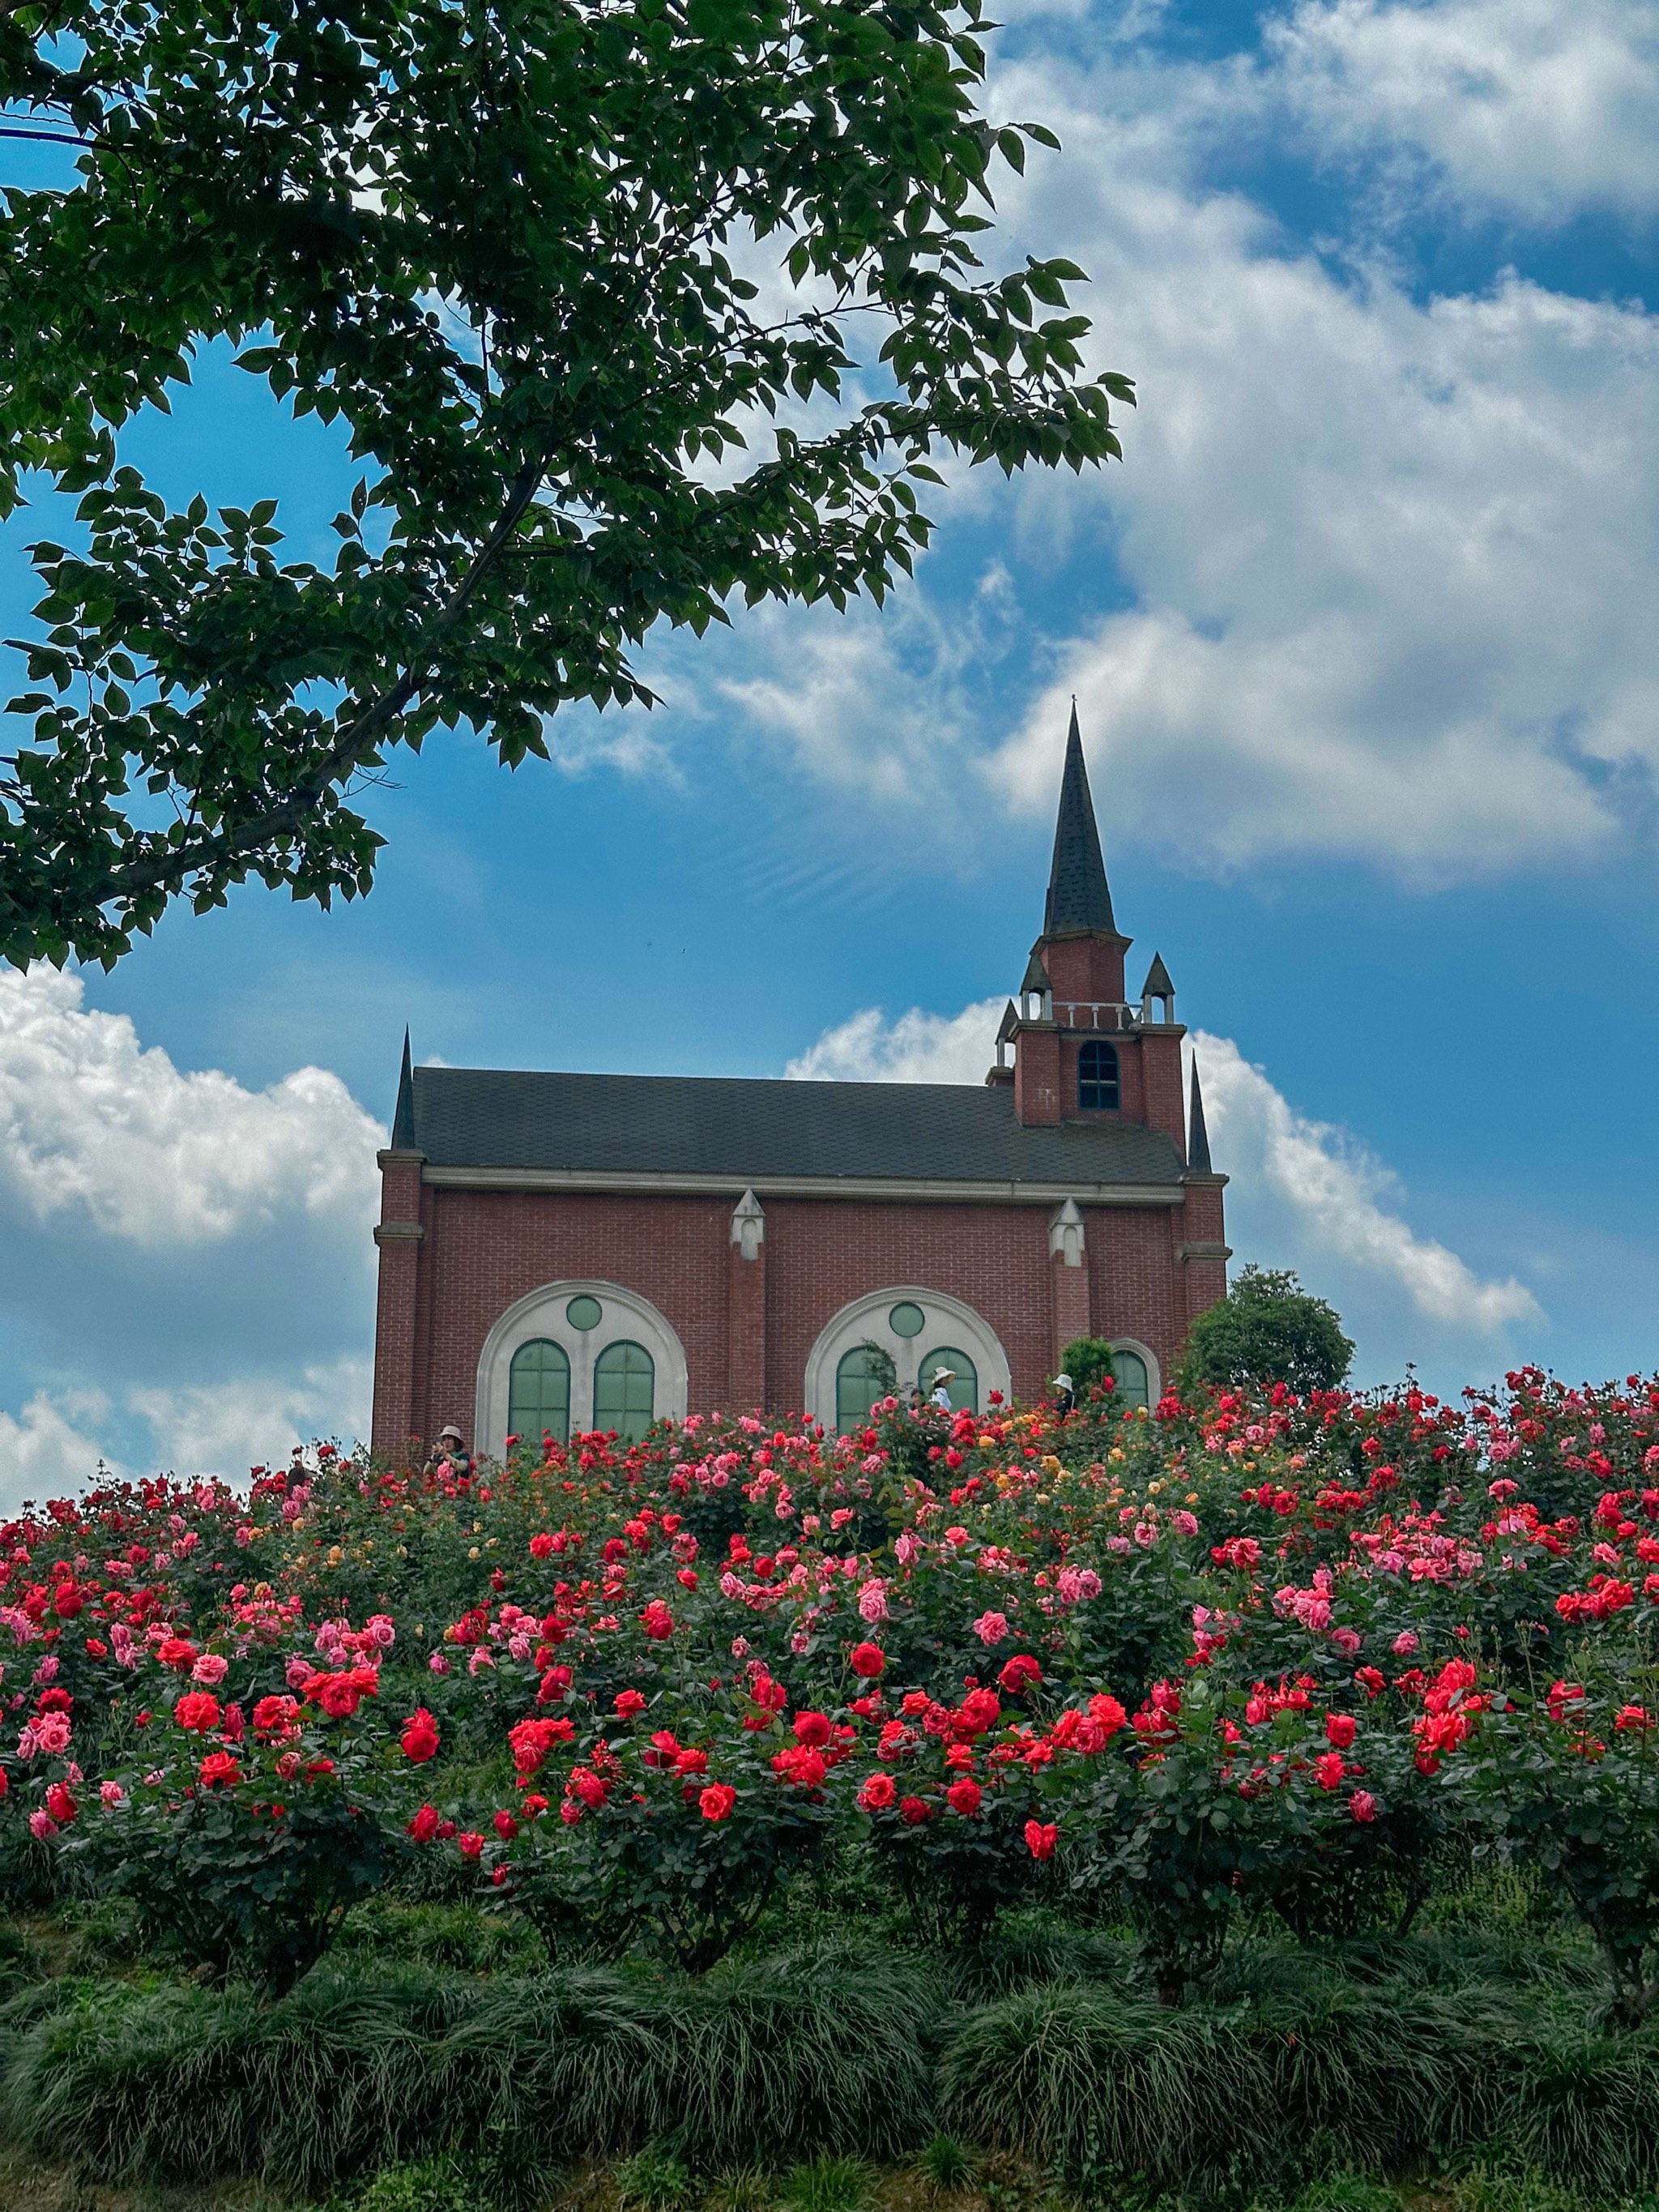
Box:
[0,0,1130,964]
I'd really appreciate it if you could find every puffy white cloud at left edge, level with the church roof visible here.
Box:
[0,967,382,1249]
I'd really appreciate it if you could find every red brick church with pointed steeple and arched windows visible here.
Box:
[373,710,1228,1454]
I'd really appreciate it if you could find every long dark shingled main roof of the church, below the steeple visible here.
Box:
[412,1069,1181,1188]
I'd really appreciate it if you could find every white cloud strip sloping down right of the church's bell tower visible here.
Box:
[1192,1031,1544,1334]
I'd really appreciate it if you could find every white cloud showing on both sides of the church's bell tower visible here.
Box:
[785,997,1544,1336]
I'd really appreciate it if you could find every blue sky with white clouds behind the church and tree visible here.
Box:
[0,0,1659,1495]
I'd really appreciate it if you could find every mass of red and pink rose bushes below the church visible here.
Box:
[0,1369,1659,2019]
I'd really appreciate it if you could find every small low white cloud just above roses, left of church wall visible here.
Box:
[128,1358,373,1482]
